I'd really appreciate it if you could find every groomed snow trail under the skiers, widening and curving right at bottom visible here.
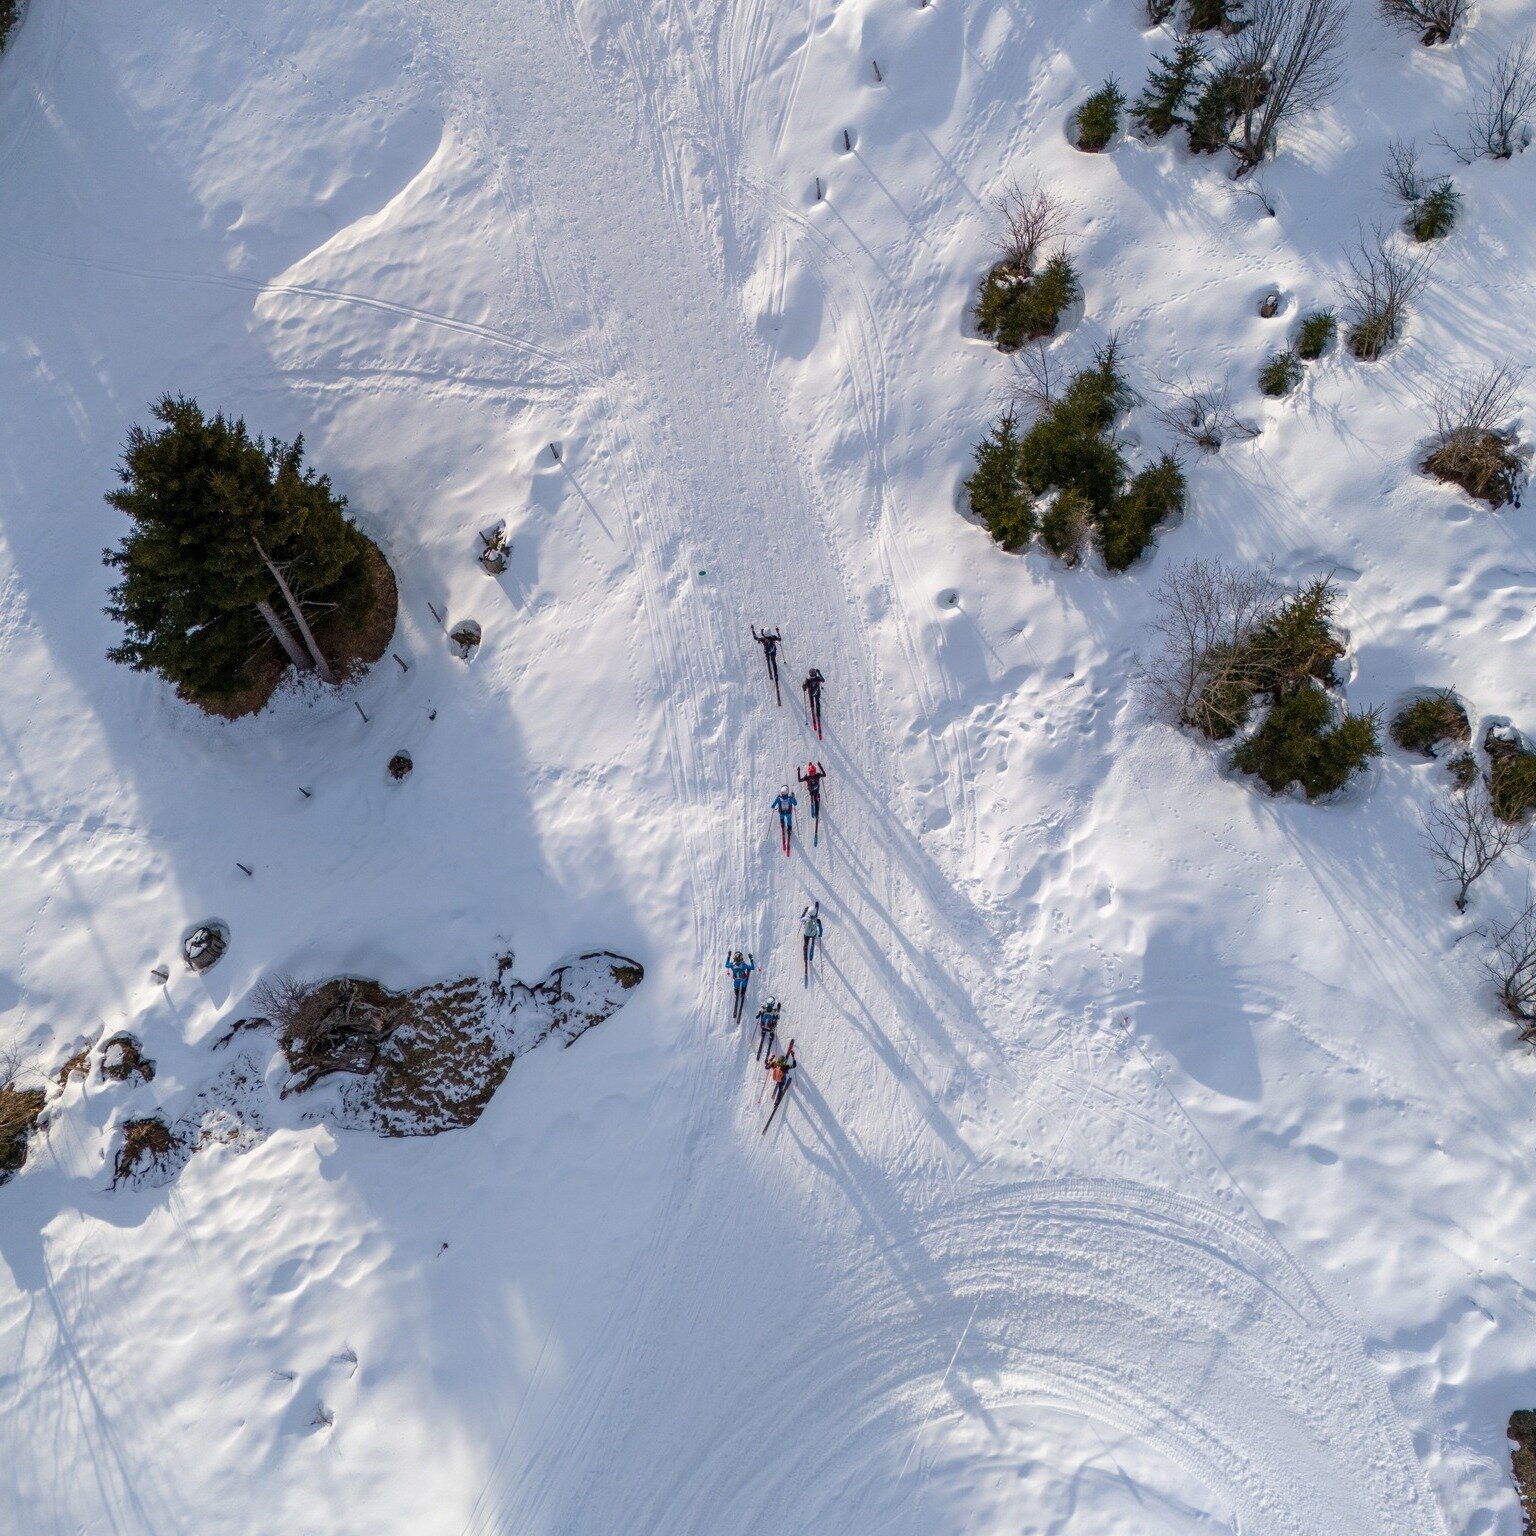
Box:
[417,6,1436,1536]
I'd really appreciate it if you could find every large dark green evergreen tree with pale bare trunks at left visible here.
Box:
[103,395,373,700]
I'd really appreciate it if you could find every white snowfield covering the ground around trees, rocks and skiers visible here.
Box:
[0,0,1536,1536]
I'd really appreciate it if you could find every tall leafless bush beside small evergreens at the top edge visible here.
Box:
[1230,0,1347,177]
